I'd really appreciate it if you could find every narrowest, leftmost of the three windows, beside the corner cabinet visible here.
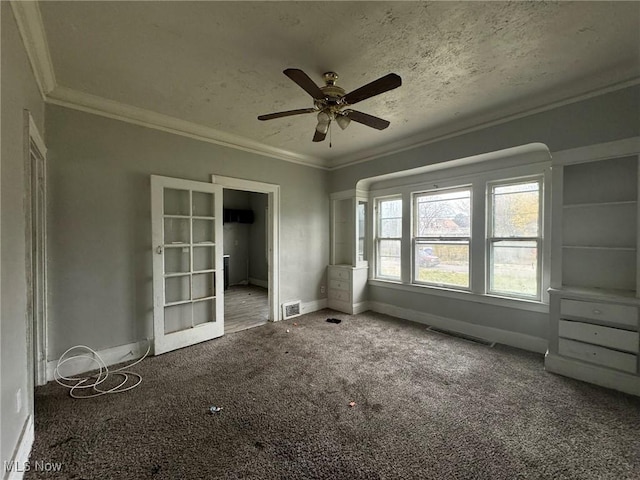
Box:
[376,197,402,280]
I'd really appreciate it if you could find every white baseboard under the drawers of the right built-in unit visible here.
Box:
[544,353,640,396]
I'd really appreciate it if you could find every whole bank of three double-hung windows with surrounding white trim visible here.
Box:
[371,149,551,311]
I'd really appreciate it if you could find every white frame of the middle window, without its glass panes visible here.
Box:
[411,183,473,292]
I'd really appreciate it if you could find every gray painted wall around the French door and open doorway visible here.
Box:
[46,105,329,359]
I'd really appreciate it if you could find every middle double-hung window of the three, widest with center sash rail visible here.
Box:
[413,187,471,289]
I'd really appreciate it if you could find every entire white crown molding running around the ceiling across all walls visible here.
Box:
[10,0,640,170]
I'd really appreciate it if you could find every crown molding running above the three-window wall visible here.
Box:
[328,77,640,170]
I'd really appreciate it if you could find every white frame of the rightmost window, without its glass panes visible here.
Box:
[484,173,546,302]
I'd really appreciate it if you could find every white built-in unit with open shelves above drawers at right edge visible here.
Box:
[545,137,640,395]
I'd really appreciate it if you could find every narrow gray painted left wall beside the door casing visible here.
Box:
[0,2,44,468]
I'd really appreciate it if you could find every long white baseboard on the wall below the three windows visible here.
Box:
[368,302,548,353]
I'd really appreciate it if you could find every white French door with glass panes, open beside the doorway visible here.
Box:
[151,175,224,355]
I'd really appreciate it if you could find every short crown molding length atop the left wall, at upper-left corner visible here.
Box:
[10,0,56,99]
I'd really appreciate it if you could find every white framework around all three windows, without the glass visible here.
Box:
[368,158,555,313]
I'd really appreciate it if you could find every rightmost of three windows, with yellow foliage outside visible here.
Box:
[487,179,542,299]
